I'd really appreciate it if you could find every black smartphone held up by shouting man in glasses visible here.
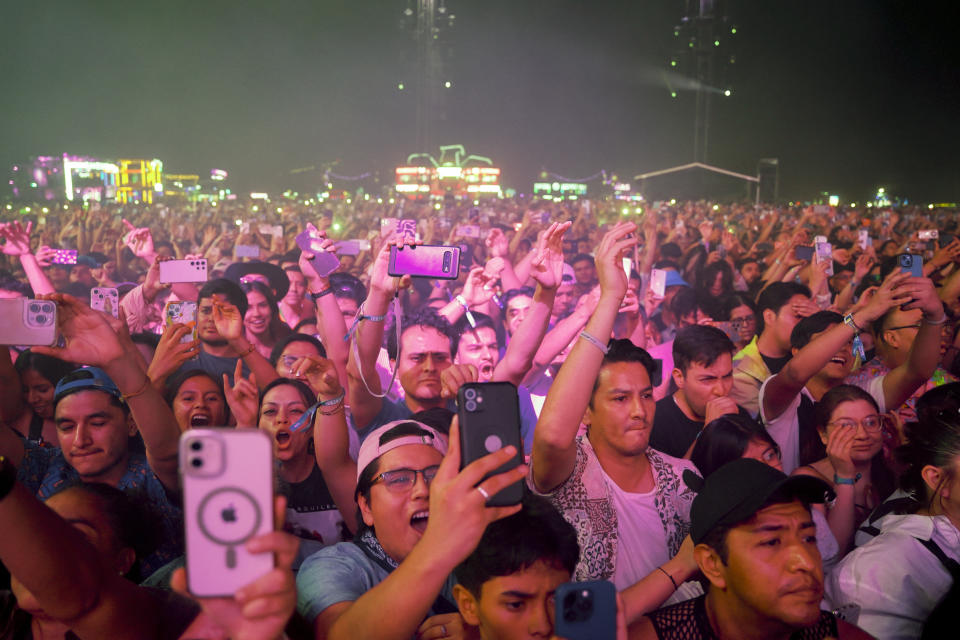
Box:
[457,382,523,507]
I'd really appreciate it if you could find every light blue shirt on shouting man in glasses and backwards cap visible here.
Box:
[297,542,456,625]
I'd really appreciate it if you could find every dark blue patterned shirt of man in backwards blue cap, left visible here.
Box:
[17,440,183,576]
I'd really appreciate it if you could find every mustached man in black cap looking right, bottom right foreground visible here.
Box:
[629,458,870,640]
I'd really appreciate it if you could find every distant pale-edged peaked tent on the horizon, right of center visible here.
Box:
[633,162,760,201]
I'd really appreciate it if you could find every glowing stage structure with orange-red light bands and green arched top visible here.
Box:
[396,144,502,200]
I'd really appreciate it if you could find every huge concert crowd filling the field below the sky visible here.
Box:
[0,199,960,640]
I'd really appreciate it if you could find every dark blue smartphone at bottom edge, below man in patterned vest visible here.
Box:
[553,580,617,640]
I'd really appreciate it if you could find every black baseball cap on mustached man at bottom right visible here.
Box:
[683,458,835,544]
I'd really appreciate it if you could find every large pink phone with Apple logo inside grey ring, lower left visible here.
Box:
[180,429,274,597]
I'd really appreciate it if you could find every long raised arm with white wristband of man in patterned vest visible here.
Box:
[532,222,637,492]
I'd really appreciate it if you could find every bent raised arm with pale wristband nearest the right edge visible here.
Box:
[883,278,949,411]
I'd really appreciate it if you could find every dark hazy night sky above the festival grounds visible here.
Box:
[0,0,960,202]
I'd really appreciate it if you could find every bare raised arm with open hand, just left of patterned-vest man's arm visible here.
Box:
[493,222,570,385]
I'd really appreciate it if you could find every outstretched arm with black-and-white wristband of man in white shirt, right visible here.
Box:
[762,271,910,420]
